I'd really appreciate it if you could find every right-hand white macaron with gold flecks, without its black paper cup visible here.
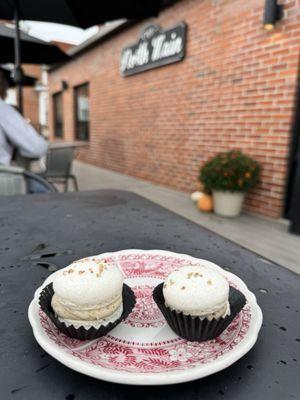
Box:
[163,263,230,320]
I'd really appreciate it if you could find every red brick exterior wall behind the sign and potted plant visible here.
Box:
[50,0,300,217]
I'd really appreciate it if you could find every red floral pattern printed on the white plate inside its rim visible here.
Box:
[39,252,251,373]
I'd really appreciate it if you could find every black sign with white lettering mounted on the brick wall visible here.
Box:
[120,22,186,76]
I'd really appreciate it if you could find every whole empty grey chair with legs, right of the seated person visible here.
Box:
[41,147,78,192]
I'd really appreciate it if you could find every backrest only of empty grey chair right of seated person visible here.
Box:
[43,147,75,177]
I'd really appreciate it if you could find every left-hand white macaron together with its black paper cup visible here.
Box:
[40,258,135,339]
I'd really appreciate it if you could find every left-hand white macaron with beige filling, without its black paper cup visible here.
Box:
[51,258,123,329]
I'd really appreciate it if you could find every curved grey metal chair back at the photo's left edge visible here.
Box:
[0,165,56,196]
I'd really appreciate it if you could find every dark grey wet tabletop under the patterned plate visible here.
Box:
[0,190,300,400]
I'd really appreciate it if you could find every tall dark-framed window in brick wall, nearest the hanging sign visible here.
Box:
[74,83,90,140]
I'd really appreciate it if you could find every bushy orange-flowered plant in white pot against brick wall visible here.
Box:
[199,150,260,217]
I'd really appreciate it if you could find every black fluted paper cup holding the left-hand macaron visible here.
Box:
[39,283,136,340]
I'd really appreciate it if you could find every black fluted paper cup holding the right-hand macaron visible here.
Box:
[153,283,246,342]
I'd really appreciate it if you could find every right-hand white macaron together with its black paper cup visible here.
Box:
[153,265,246,341]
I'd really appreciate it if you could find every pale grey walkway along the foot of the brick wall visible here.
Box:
[73,161,300,274]
